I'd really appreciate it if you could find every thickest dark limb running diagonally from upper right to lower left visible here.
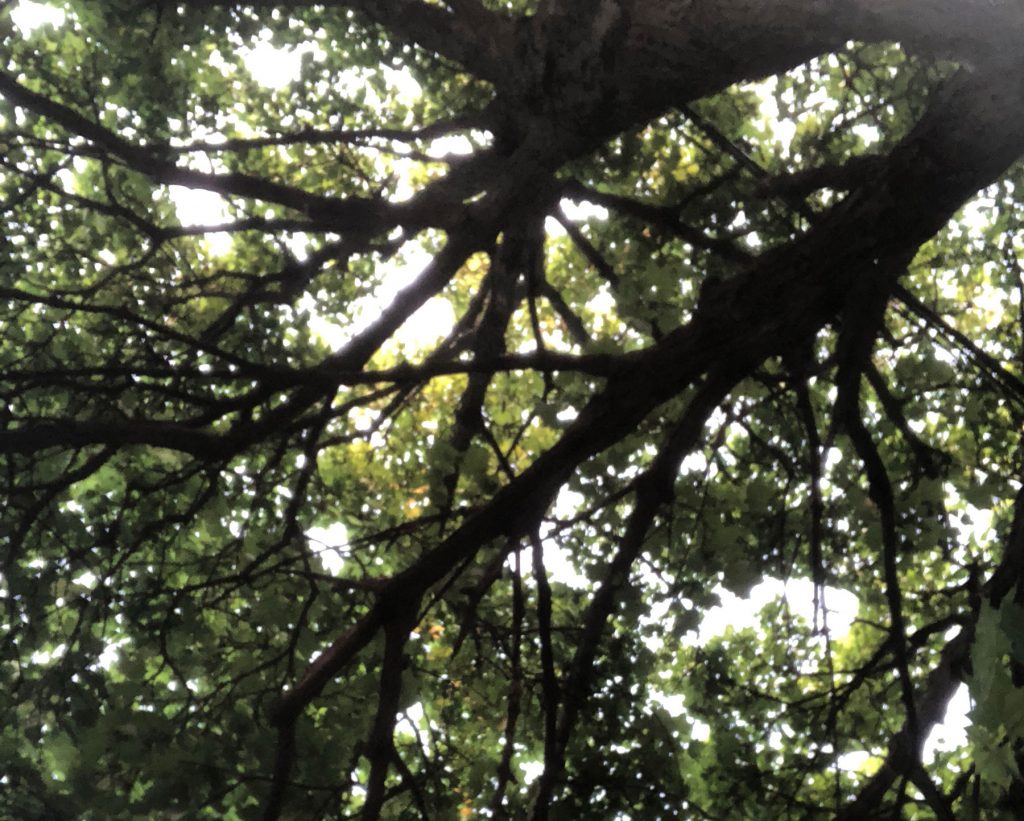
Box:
[268,62,1024,737]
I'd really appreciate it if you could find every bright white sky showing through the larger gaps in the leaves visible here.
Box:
[10,0,978,782]
